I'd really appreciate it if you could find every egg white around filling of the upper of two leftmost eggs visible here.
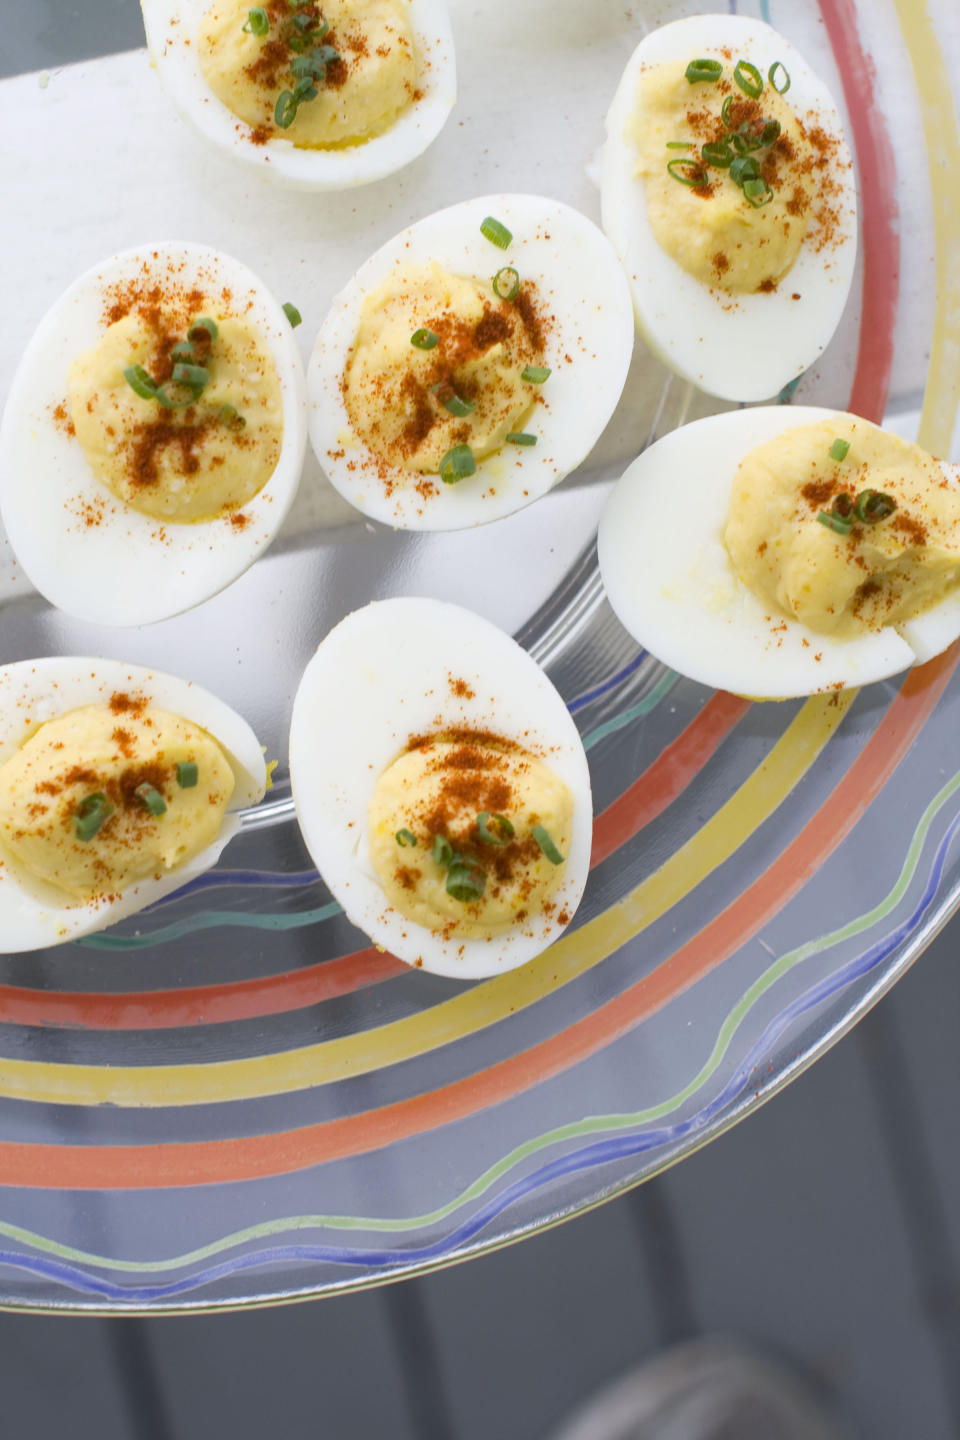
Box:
[0,242,307,625]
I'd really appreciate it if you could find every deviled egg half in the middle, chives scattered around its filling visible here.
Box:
[307,194,633,530]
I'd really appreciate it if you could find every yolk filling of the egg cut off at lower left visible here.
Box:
[0,694,235,903]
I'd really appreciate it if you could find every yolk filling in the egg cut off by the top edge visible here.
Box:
[197,0,417,148]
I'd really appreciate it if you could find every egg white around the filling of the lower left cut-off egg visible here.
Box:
[0,655,266,955]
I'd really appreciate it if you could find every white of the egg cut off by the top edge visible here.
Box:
[141,0,456,190]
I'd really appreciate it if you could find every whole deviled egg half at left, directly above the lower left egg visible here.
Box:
[0,242,307,625]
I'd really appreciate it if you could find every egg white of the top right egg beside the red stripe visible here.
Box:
[602,14,856,400]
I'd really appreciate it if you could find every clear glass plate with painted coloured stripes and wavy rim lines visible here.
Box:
[0,0,960,1310]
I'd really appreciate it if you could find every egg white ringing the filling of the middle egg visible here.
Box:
[307,194,633,530]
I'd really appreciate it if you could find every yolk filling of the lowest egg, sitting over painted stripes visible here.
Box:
[370,732,573,939]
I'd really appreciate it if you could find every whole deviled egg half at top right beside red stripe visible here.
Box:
[602,14,856,400]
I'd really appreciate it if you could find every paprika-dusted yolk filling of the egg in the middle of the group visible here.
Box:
[343,264,544,474]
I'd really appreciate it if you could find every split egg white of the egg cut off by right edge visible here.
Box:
[597,406,960,700]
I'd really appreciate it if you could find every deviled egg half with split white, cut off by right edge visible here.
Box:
[597,406,960,700]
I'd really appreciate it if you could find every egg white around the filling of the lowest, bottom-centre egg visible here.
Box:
[289,599,593,979]
